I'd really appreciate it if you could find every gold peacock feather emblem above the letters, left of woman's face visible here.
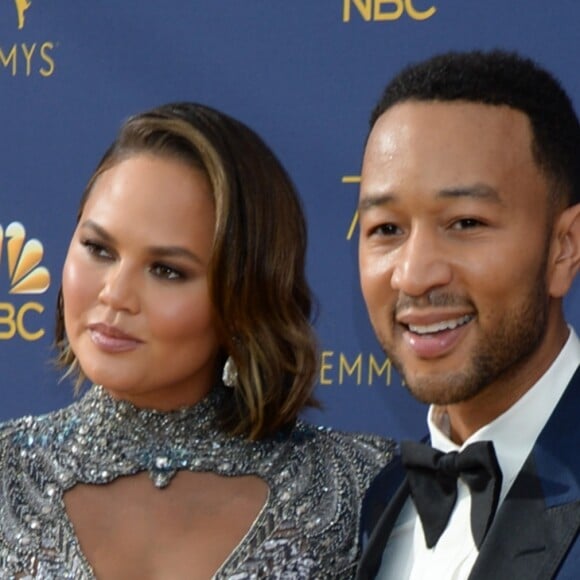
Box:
[0,222,50,294]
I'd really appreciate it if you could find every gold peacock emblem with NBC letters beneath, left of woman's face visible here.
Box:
[0,222,50,341]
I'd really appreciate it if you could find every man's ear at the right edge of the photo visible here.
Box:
[548,203,580,298]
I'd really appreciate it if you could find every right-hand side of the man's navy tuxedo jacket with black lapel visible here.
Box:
[470,371,580,580]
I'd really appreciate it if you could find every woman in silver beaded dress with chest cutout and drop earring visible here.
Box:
[0,103,391,580]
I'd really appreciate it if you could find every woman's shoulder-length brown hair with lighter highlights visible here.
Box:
[56,103,317,439]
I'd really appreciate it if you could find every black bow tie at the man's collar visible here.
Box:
[401,441,502,548]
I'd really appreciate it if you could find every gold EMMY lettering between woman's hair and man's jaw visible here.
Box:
[318,350,393,387]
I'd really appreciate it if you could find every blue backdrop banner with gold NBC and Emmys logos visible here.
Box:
[0,0,580,437]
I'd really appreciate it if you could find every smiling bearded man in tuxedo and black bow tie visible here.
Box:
[358,51,580,580]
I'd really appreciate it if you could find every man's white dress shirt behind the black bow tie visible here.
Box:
[377,329,580,580]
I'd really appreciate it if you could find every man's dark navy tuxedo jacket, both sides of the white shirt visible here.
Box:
[357,369,580,580]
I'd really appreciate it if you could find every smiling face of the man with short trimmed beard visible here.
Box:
[359,101,551,404]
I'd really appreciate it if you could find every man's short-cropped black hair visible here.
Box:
[370,50,580,206]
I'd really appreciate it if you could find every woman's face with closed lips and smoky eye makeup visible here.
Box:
[62,154,219,410]
